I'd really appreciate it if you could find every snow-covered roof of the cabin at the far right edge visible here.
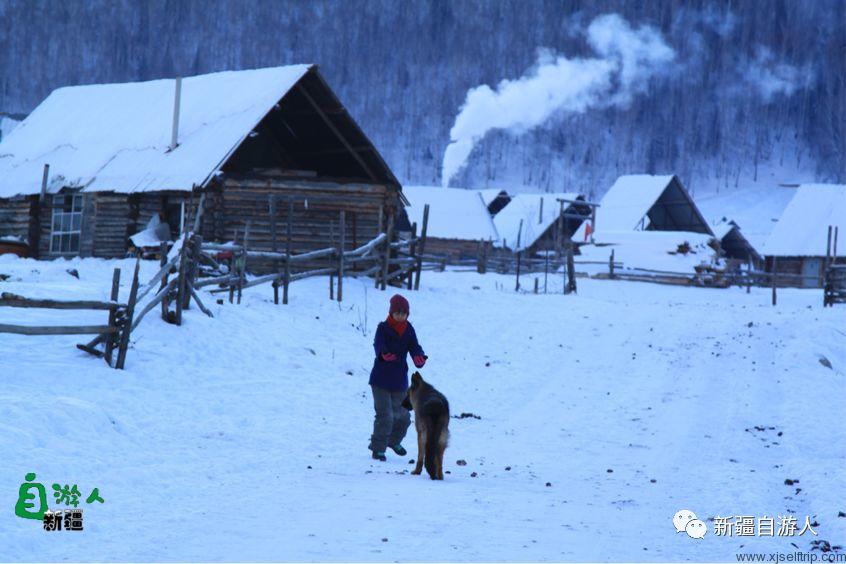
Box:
[762,184,846,257]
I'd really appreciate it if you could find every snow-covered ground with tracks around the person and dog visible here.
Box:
[0,255,846,561]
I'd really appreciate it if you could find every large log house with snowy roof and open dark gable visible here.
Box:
[0,65,403,266]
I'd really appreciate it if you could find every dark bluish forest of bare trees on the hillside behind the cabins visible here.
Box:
[0,0,846,195]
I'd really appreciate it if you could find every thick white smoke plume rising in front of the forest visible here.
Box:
[441,14,675,186]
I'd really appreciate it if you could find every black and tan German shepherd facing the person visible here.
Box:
[402,372,449,480]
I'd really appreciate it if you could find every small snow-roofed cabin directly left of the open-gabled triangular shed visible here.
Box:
[494,192,591,256]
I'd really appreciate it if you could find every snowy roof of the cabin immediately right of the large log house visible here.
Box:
[402,186,499,241]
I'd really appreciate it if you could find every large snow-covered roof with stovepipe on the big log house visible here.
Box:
[0,65,311,197]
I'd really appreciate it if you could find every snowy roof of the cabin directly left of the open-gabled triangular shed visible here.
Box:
[494,192,579,251]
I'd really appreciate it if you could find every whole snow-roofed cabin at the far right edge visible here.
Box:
[763,184,846,288]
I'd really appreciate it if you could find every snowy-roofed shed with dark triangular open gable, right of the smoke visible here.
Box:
[575,174,714,241]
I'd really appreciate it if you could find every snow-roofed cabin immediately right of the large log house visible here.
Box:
[402,186,499,262]
